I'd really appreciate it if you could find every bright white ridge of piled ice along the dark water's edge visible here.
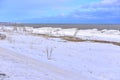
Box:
[0,26,120,42]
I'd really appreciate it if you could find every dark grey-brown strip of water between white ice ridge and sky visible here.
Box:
[0,22,120,30]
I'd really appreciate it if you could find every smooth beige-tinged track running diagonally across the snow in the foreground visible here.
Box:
[0,48,89,80]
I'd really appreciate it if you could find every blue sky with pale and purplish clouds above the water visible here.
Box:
[0,0,120,24]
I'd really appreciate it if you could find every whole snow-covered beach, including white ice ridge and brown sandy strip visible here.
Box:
[0,27,120,80]
